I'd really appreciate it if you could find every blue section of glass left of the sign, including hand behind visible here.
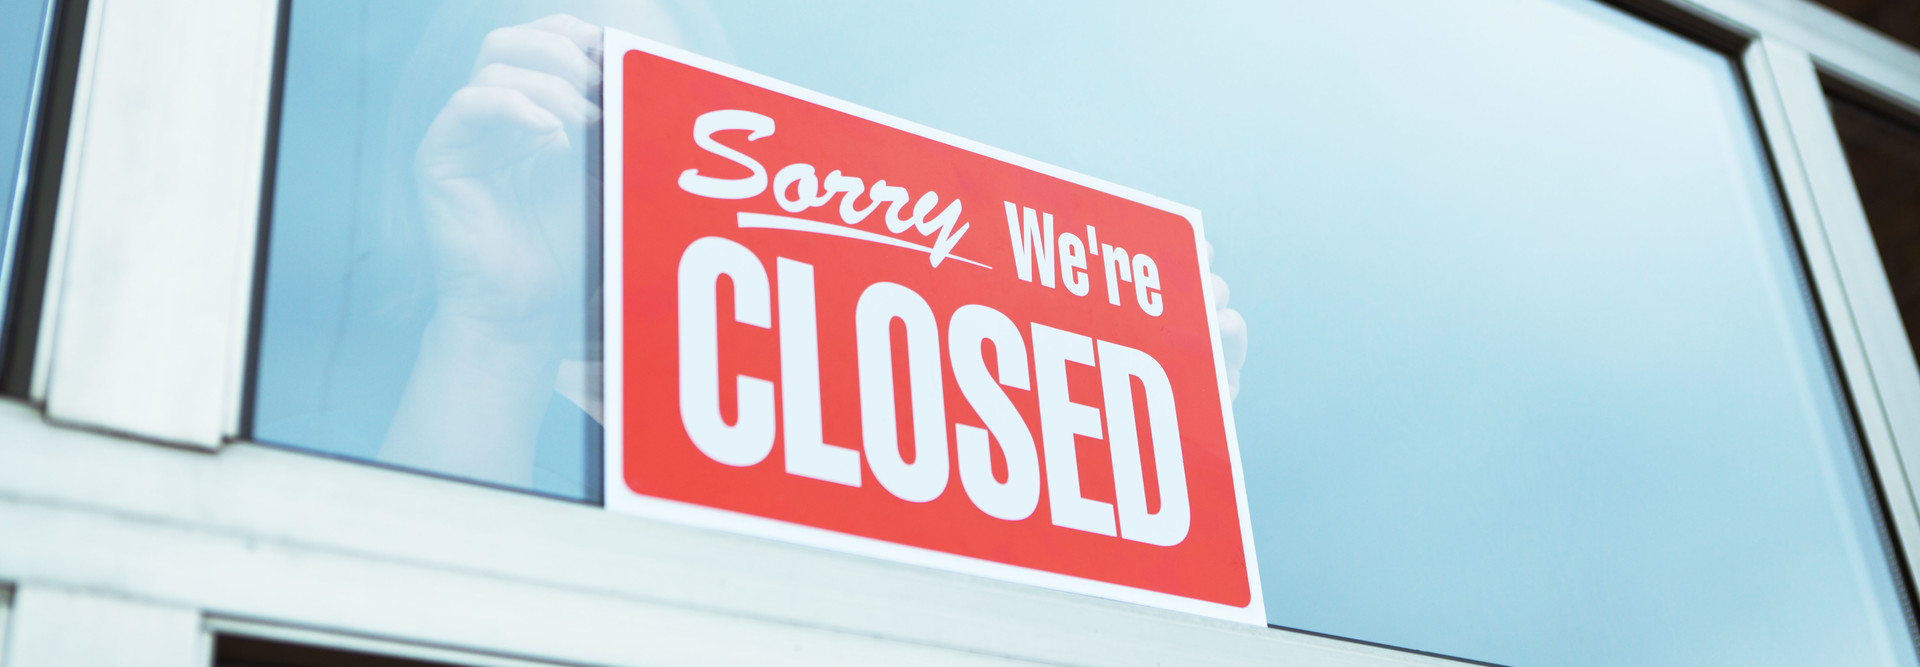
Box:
[253,0,718,500]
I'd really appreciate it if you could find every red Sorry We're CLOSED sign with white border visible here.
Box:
[605,33,1265,623]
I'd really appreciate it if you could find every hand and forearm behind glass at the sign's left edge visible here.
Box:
[378,15,601,486]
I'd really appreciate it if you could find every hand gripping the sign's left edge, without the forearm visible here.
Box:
[415,13,601,348]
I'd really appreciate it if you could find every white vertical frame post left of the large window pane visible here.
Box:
[33,0,278,448]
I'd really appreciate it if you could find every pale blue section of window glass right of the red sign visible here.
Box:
[716,0,1914,665]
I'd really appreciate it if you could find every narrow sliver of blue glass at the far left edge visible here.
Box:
[0,0,48,330]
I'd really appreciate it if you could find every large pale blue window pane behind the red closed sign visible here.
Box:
[266,0,1914,665]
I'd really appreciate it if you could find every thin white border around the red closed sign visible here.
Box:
[601,29,1267,627]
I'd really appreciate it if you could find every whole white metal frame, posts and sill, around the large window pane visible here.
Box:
[11,0,1920,667]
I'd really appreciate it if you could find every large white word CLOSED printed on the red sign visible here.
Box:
[678,236,1188,546]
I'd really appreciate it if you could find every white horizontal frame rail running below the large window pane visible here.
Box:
[0,402,1448,667]
